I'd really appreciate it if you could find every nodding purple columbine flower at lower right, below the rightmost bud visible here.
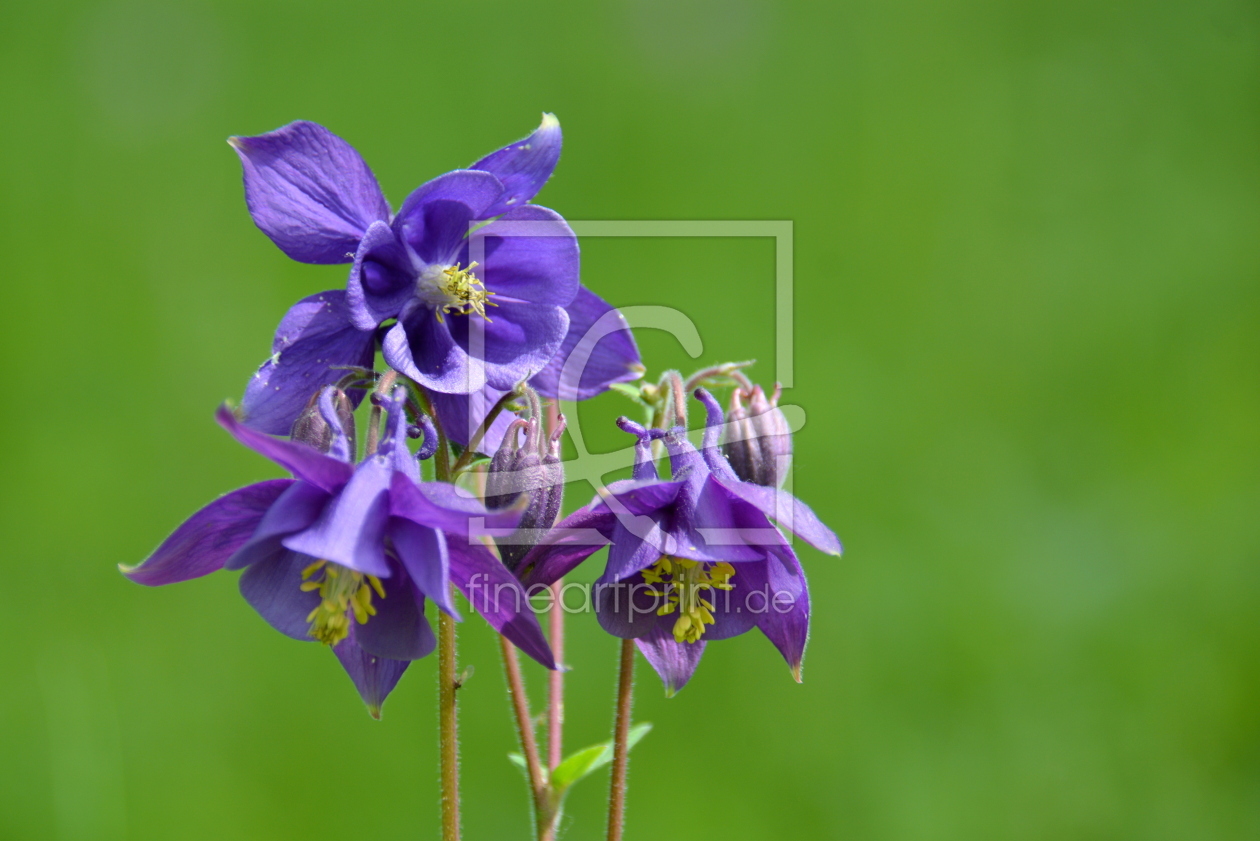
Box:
[519,388,840,693]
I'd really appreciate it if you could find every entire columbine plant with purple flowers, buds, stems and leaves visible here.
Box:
[122,115,840,841]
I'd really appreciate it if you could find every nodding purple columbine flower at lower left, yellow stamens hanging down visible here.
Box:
[122,387,556,717]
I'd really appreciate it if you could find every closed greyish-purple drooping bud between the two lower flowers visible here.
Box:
[485,415,564,570]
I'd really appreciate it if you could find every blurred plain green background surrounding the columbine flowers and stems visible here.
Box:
[0,0,1260,841]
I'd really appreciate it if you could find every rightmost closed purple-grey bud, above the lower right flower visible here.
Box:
[722,385,791,488]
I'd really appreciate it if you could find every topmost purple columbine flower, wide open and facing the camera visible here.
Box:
[229,115,639,434]
